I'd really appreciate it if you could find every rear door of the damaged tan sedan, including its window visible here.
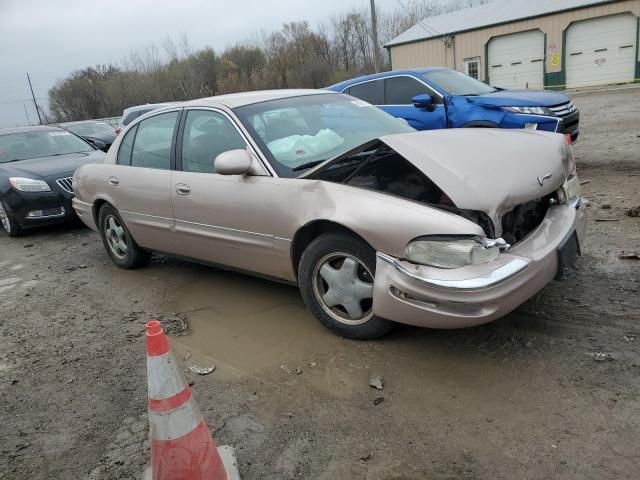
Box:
[108,109,181,252]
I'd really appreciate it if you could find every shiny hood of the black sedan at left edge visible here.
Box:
[0,150,105,179]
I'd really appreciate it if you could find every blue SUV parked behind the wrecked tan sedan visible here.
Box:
[328,67,580,142]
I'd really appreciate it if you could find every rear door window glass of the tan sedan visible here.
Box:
[131,112,178,170]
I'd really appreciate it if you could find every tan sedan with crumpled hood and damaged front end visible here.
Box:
[73,90,585,338]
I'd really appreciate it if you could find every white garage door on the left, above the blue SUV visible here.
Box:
[489,30,544,89]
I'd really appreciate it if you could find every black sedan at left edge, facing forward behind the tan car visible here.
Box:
[0,127,105,237]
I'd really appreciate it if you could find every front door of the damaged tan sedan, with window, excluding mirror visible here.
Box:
[171,109,282,276]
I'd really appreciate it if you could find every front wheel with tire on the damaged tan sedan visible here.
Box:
[298,234,393,340]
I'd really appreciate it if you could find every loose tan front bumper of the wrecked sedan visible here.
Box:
[373,197,586,328]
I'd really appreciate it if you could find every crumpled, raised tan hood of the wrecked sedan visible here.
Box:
[380,128,571,221]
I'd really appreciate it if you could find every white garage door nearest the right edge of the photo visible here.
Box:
[565,14,638,87]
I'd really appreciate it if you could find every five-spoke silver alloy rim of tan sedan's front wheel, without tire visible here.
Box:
[313,253,373,325]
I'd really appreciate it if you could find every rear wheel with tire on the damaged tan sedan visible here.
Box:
[98,205,151,269]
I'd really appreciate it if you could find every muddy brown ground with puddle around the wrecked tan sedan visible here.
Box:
[0,84,640,480]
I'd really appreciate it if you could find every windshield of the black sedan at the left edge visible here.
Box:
[0,130,94,163]
